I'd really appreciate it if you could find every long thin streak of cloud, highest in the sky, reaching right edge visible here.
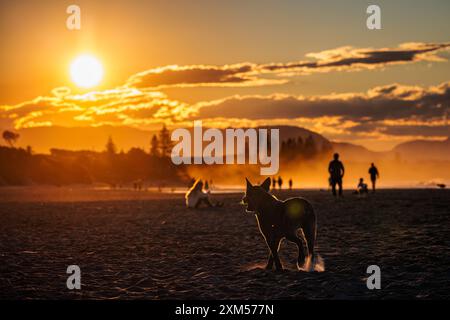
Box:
[127,42,450,89]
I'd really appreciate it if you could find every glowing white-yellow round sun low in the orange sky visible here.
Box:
[70,54,103,88]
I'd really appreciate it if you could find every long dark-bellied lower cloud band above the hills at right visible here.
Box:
[196,82,450,121]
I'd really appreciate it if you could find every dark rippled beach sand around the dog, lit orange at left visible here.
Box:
[0,187,450,299]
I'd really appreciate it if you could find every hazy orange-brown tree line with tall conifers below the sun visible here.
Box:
[0,126,190,187]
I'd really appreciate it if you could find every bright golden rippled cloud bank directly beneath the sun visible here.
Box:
[0,88,195,129]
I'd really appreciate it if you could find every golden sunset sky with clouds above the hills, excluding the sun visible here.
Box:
[0,0,450,150]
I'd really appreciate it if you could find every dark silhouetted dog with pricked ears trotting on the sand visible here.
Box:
[242,178,316,271]
